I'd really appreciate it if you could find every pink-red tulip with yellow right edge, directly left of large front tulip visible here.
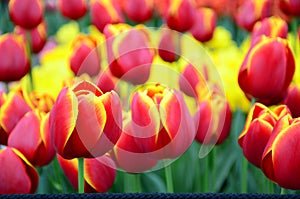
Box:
[8,111,55,166]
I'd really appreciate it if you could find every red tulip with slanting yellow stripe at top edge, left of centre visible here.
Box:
[90,0,124,32]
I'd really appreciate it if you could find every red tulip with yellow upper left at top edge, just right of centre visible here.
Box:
[164,0,196,32]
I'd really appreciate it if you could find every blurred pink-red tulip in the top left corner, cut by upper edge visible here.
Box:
[8,0,44,29]
